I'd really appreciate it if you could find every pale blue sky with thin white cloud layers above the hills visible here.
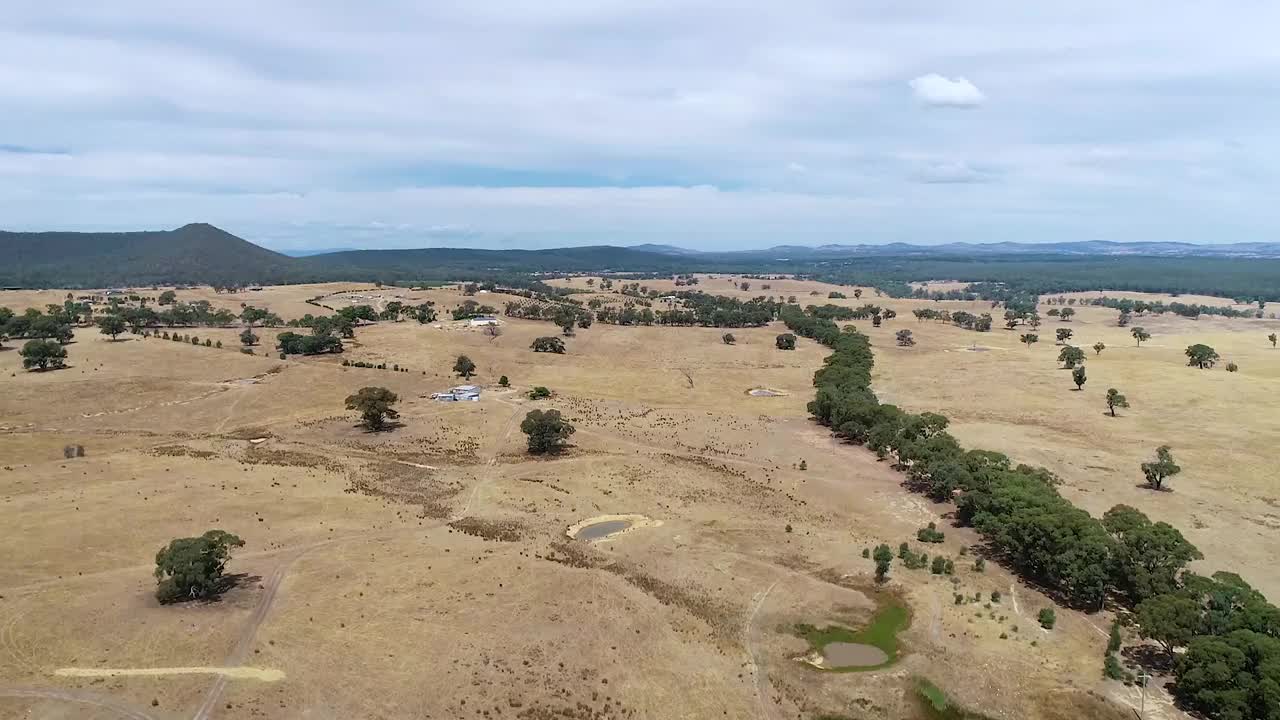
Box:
[0,0,1280,250]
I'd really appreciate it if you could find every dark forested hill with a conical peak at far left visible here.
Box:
[0,223,293,287]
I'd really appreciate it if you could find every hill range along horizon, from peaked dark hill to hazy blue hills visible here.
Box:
[0,223,1280,287]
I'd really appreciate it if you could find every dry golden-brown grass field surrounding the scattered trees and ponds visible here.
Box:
[0,278,1259,720]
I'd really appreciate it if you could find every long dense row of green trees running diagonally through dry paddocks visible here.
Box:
[781,306,1280,720]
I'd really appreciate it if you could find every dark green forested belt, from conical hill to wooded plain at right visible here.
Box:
[0,223,1280,302]
